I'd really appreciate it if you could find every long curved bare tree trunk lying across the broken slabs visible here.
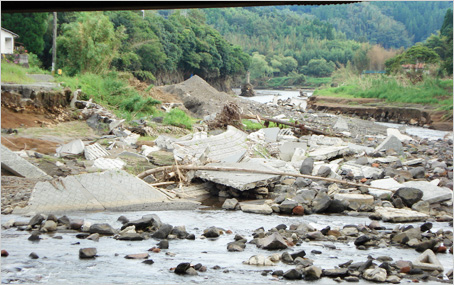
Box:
[137,165,395,192]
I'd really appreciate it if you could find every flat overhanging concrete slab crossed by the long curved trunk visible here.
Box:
[195,161,280,191]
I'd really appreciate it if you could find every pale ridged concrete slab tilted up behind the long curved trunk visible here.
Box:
[173,126,248,162]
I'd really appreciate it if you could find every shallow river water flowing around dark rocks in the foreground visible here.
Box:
[1,210,453,284]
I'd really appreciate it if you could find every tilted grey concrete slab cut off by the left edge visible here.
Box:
[1,145,49,178]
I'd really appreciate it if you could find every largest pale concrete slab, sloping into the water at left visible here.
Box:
[13,170,199,214]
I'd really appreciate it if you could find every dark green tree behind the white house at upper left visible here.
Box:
[1,13,48,55]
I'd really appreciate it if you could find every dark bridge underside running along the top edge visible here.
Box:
[1,1,362,13]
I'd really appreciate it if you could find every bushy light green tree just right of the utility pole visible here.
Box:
[57,12,125,74]
